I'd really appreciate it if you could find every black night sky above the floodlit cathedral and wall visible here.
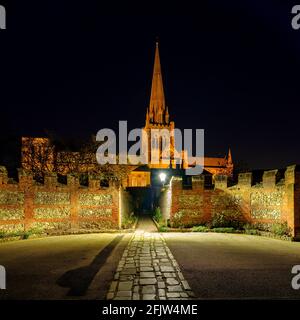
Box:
[0,0,300,168]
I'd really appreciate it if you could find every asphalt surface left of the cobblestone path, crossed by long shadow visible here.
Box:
[0,234,130,300]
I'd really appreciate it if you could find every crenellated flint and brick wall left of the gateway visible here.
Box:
[0,167,126,233]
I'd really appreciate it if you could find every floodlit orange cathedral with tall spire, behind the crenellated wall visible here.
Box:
[22,43,233,187]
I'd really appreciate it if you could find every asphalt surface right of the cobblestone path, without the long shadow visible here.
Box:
[164,233,300,299]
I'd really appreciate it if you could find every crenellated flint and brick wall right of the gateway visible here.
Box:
[166,166,300,237]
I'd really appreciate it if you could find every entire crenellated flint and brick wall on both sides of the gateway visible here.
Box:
[0,162,300,237]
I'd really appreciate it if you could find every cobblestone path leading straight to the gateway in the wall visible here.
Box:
[107,218,194,300]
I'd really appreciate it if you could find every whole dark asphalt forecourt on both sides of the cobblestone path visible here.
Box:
[0,231,300,299]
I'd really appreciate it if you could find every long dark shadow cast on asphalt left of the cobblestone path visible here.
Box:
[56,235,124,296]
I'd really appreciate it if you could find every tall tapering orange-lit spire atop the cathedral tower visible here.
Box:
[149,42,165,123]
